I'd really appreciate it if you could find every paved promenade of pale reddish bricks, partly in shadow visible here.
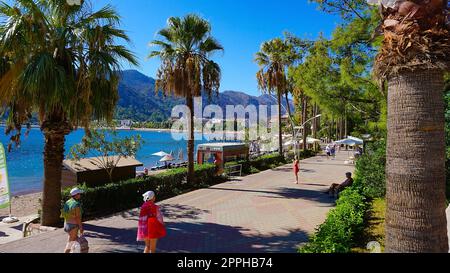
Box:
[0,151,353,253]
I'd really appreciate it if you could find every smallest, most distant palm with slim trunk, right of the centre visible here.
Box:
[255,38,296,156]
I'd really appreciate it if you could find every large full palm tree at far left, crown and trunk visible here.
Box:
[0,0,137,226]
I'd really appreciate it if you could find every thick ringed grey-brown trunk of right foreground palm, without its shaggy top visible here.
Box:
[386,70,448,253]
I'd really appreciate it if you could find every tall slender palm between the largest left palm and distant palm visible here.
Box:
[149,14,223,185]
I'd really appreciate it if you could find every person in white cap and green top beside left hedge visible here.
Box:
[61,188,84,253]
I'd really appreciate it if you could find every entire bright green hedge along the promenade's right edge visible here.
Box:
[299,141,386,253]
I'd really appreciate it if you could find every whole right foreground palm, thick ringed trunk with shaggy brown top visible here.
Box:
[375,1,450,252]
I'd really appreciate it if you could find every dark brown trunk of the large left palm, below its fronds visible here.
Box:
[41,122,70,226]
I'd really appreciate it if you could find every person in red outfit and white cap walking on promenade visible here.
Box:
[137,191,167,253]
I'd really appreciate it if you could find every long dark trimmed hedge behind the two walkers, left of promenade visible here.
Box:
[62,165,220,218]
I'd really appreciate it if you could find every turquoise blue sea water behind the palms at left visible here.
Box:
[0,127,213,195]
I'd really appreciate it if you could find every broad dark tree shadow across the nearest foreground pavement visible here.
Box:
[92,222,308,253]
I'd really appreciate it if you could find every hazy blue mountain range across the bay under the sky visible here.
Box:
[116,70,293,122]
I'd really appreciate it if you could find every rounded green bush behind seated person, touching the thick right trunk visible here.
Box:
[355,140,386,198]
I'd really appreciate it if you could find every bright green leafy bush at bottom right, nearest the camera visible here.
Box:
[299,187,368,253]
